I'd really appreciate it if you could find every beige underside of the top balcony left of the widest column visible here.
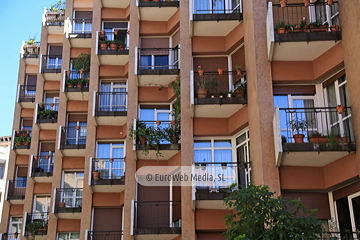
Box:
[192,13,242,37]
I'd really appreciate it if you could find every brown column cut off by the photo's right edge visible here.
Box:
[339,0,360,175]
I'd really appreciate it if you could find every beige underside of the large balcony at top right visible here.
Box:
[272,35,341,61]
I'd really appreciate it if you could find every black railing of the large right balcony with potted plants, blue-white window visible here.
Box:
[279,107,355,144]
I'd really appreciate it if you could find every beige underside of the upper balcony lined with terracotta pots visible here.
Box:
[98,49,129,66]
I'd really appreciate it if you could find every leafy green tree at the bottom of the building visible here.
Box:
[224,184,323,240]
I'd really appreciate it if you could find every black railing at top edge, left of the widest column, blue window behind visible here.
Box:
[194,0,242,14]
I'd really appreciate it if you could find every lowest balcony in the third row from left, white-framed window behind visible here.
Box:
[53,188,83,219]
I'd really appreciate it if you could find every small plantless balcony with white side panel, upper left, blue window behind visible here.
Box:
[40,55,62,81]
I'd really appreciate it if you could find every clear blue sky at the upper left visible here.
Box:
[0,0,57,137]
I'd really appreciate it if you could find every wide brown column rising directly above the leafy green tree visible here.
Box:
[243,0,280,194]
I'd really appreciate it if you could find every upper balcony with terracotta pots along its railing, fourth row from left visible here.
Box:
[97,30,129,66]
